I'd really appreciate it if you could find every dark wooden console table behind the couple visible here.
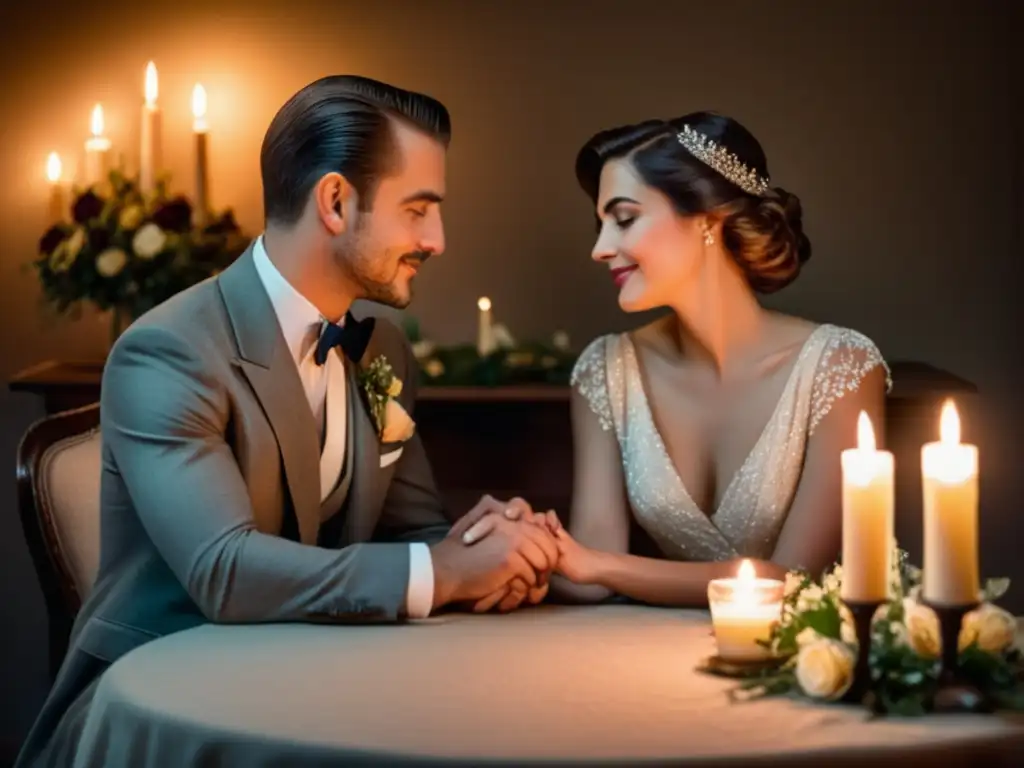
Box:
[9,361,978,558]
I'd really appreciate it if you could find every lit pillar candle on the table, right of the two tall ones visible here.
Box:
[921,400,979,605]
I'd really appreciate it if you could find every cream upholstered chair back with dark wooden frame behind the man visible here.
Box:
[17,403,101,674]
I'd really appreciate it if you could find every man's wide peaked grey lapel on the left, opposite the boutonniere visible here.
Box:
[217,246,321,544]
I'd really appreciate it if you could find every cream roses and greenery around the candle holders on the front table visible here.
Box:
[734,549,1024,715]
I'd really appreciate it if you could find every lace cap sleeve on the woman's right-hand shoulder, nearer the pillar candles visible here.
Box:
[808,328,893,434]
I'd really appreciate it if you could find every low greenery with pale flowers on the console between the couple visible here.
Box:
[406,318,578,387]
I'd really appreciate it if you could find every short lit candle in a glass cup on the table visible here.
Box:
[708,560,783,662]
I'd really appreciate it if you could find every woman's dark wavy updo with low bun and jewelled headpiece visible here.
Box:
[575,112,811,294]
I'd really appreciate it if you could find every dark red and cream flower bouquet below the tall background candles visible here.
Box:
[33,170,249,346]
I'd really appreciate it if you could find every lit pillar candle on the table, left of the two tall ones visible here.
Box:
[841,411,895,602]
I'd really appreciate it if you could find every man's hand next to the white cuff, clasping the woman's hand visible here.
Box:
[431,507,558,608]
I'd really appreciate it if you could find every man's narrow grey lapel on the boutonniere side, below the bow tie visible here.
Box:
[344,358,380,544]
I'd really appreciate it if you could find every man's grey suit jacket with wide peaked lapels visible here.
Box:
[18,243,449,765]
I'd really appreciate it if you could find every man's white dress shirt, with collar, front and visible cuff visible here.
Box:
[253,236,434,618]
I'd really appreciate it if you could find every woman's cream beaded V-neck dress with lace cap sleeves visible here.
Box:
[571,325,891,561]
